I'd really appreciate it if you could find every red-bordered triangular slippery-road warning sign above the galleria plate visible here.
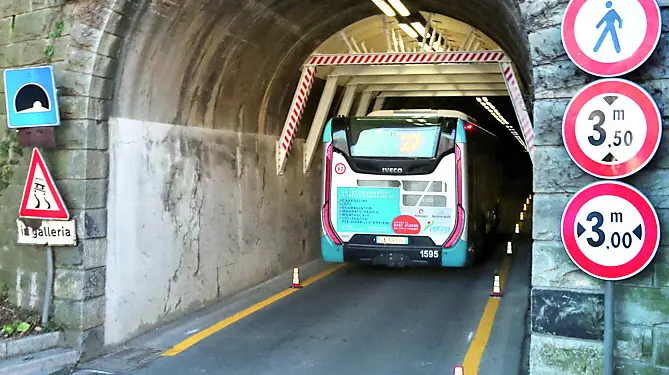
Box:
[19,148,70,220]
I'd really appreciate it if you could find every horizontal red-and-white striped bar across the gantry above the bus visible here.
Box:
[305,51,506,66]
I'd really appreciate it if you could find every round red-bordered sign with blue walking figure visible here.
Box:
[562,0,662,77]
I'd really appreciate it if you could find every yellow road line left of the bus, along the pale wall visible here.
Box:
[160,263,346,357]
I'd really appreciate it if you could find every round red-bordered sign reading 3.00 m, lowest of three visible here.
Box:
[561,181,660,280]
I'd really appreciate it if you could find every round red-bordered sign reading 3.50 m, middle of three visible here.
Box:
[562,78,662,179]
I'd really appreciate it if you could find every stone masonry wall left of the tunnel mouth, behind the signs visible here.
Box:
[0,0,132,356]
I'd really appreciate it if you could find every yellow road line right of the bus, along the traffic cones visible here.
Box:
[462,256,511,375]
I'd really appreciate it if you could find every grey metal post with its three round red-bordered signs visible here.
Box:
[561,0,662,375]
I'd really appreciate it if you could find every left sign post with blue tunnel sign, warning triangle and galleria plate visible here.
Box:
[3,65,68,326]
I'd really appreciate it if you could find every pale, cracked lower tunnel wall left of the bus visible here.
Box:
[105,118,320,345]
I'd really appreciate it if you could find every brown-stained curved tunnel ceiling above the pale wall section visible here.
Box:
[113,0,530,135]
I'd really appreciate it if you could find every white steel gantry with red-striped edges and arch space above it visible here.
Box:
[277,12,534,174]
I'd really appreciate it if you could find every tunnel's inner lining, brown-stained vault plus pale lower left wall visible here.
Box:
[105,0,532,345]
